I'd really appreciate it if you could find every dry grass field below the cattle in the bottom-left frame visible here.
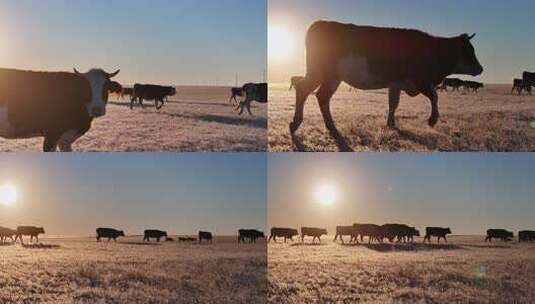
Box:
[0,237,267,304]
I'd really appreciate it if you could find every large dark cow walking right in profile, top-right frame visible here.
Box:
[290,21,483,141]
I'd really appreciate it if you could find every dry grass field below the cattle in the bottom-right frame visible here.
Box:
[268,236,535,303]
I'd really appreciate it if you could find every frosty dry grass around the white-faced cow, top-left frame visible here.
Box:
[0,87,267,151]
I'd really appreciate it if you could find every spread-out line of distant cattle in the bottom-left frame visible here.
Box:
[0,226,265,244]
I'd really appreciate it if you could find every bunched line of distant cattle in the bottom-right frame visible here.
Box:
[268,223,535,244]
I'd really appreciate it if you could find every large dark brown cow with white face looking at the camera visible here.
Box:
[0,69,119,152]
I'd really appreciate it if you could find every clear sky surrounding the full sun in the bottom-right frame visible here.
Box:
[268,153,535,234]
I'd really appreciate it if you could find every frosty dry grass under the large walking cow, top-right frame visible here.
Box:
[268,85,535,152]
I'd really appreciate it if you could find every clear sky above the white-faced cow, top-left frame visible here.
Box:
[0,0,267,85]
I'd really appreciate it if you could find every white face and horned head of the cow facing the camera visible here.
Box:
[74,69,120,117]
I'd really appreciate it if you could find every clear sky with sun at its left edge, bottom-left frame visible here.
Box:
[0,153,267,236]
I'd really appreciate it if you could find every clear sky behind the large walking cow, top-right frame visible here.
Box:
[268,0,535,83]
